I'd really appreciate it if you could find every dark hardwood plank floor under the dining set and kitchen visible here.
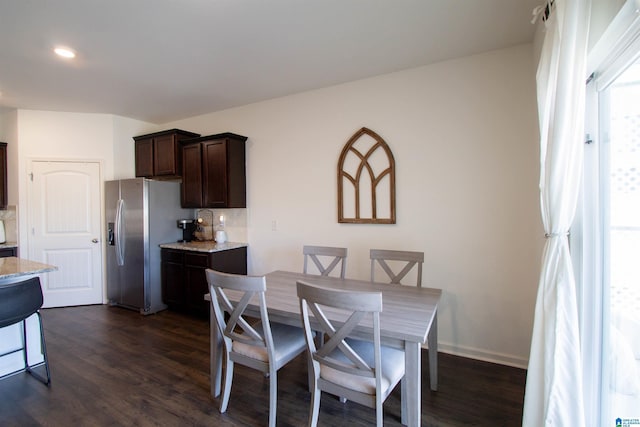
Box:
[0,306,525,427]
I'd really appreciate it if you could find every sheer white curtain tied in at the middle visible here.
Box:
[523,0,591,427]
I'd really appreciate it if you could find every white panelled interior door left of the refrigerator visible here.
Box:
[28,161,103,307]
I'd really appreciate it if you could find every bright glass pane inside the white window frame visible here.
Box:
[600,57,640,425]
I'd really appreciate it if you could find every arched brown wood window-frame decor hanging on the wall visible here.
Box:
[338,128,396,224]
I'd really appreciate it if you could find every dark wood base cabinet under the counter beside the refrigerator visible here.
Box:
[162,247,247,317]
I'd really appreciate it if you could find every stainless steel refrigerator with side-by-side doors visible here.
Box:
[105,178,193,314]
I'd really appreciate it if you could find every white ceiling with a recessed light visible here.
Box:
[0,0,542,123]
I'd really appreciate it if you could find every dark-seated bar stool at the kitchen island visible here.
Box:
[0,277,51,387]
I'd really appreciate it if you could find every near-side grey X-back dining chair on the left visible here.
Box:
[206,269,306,427]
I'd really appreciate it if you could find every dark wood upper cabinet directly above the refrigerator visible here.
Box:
[133,129,200,179]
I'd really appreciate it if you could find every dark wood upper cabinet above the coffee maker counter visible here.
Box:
[181,133,247,208]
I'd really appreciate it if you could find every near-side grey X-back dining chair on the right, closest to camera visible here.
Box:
[296,281,405,427]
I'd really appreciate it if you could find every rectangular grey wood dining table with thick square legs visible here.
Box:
[205,270,442,426]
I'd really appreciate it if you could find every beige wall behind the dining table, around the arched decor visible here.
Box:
[164,45,543,366]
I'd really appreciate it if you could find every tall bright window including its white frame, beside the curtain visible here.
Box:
[572,5,640,426]
